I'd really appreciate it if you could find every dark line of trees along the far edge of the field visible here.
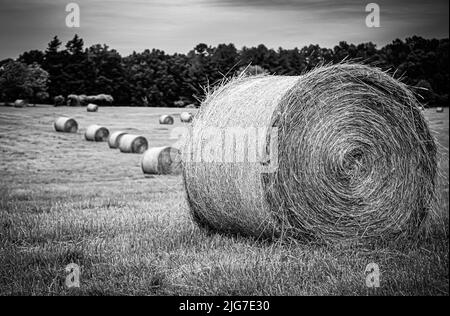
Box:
[0,35,449,107]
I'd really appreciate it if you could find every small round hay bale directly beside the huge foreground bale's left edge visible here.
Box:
[141,147,181,175]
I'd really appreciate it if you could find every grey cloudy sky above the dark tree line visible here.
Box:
[0,0,449,59]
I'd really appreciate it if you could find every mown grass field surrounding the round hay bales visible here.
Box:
[0,106,449,295]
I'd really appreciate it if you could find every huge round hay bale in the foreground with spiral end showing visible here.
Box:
[183,64,437,241]
